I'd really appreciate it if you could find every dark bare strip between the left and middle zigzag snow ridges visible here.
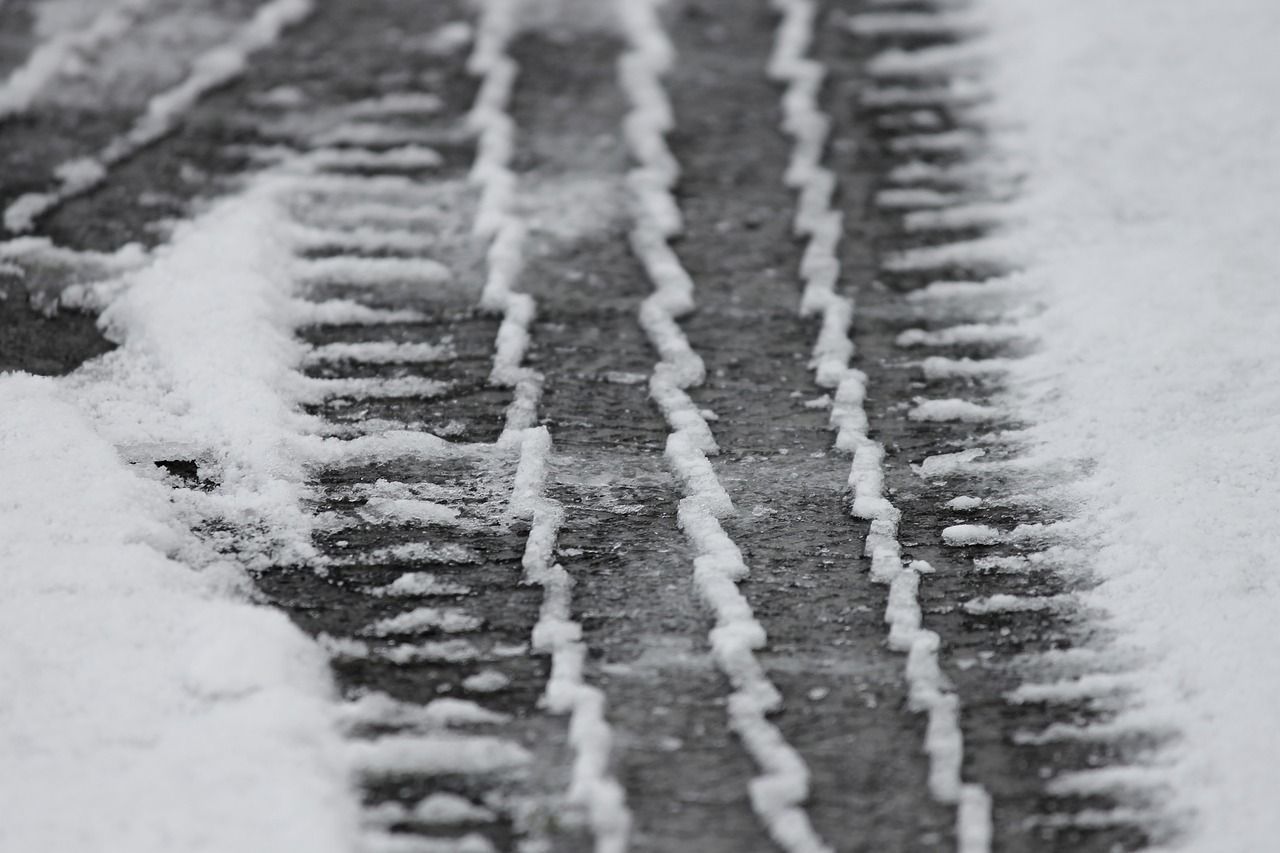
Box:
[512,23,769,853]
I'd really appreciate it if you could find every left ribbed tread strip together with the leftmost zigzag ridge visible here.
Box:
[192,9,586,852]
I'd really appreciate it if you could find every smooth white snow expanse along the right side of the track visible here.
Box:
[980,0,1280,853]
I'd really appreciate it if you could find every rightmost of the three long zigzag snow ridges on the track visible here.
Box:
[768,0,991,853]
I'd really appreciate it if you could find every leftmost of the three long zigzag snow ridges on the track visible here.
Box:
[467,0,631,853]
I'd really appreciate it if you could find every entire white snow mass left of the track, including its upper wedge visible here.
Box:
[0,182,357,853]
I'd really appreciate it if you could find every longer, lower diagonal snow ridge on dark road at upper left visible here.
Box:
[4,0,315,232]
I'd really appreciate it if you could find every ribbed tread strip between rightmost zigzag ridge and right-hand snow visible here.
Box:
[823,4,1166,850]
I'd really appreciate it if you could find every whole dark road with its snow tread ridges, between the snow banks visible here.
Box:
[0,0,1161,853]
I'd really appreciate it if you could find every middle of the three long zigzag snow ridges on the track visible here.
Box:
[617,0,832,853]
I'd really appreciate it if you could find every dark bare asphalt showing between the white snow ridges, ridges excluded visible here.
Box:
[0,0,1153,853]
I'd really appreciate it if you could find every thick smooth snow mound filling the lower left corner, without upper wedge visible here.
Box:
[0,375,356,853]
